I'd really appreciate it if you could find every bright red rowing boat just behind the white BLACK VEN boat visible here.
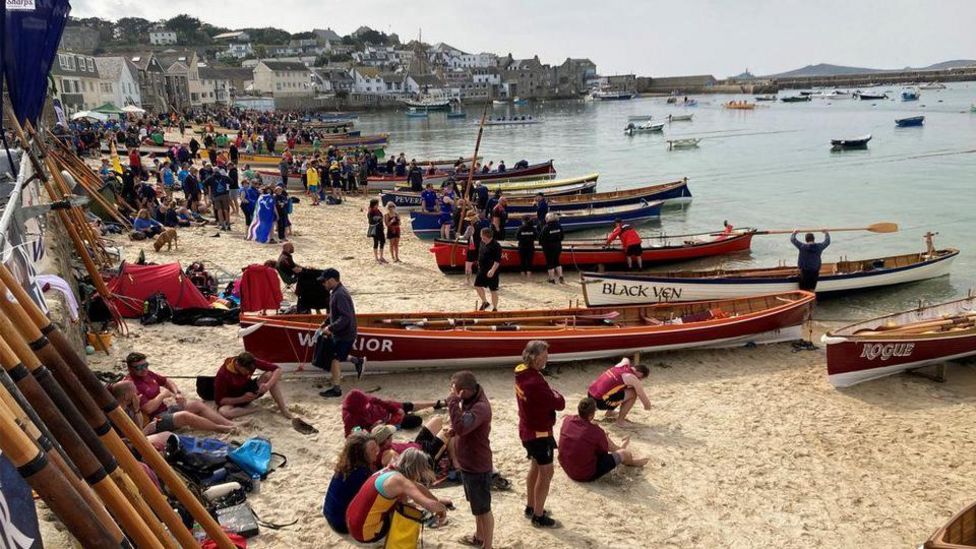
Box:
[430,230,755,273]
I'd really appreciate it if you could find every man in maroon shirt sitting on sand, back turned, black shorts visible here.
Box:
[559,397,649,482]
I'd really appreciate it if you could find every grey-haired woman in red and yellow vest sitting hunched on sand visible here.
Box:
[346,448,454,547]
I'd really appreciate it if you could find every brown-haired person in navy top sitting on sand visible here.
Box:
[322,431,380,534]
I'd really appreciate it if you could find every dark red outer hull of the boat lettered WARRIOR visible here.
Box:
[241,292,814,371]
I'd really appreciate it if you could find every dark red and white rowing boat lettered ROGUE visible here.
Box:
[821,297,976,387]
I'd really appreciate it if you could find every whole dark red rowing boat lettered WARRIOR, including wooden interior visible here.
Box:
[241,291,814,371]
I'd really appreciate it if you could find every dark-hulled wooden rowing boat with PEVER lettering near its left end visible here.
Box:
[380,179,692,211]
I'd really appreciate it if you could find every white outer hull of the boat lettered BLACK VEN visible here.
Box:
[581,252,958,307]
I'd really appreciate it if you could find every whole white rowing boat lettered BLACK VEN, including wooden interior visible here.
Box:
[581,249,959,306]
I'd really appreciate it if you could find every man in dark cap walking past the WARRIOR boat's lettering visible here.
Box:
[312,268,366,398]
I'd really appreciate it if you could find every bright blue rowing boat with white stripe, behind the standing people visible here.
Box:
[410,200,664,238]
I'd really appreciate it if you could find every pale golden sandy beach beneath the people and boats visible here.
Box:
[24,186,976,549]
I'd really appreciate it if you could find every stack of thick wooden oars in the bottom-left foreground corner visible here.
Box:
[0,264,233,549]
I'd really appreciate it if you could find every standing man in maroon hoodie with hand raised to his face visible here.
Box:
[447,371,495,549]
